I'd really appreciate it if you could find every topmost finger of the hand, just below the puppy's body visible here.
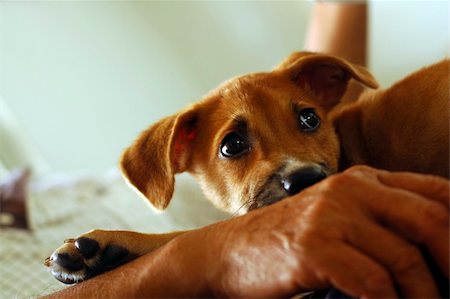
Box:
[377,171,450,208]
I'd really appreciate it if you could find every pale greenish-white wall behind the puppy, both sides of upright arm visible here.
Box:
[0,1,448,176]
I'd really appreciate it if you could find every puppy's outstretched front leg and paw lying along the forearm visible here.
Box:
[44,230,184,284]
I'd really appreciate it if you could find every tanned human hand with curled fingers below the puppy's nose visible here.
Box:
[200,166,449,297]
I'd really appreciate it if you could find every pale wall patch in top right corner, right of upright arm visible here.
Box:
[369,0,450,86]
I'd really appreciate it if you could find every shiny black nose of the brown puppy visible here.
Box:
[281,166,327,195]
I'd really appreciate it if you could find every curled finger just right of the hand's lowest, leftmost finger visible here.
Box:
[349,220,439,298]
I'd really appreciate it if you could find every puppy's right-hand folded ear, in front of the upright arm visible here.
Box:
[275,52,378,109]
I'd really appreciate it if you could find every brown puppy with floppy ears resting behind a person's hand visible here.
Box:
[46,52,449,283]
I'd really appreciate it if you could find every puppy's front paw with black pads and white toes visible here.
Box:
[44,230,137,284]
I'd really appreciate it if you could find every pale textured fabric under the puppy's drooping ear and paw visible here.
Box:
[0,174,227,298]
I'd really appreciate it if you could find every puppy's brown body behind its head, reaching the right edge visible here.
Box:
[333,60,450,178]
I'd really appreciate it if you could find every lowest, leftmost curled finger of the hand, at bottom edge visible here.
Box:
[311,243,398,298]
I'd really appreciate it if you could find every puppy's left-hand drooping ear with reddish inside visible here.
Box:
[120,109,197,210]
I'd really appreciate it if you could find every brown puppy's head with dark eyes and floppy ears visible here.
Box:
[121,52,377,214]
